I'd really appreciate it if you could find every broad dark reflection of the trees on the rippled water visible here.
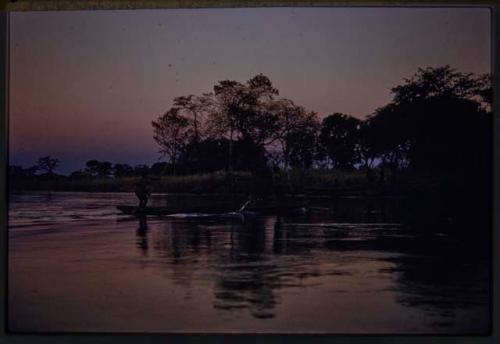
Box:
[133,207,489,327]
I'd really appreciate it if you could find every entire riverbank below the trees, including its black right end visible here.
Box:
[9,170,491,241]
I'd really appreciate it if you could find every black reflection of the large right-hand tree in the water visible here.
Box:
[386,228,491,327]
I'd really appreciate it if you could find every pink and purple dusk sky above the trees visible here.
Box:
[9,8,491,173]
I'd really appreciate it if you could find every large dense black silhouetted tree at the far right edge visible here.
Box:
[368,66,491,171]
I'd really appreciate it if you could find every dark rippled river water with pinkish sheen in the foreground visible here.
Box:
[8,193,490,334]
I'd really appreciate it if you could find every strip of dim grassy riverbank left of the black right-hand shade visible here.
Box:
[9,170,386,195]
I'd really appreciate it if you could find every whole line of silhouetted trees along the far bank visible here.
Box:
[10,66,492,188]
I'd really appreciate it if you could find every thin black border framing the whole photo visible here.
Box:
[0,0,500,344]
